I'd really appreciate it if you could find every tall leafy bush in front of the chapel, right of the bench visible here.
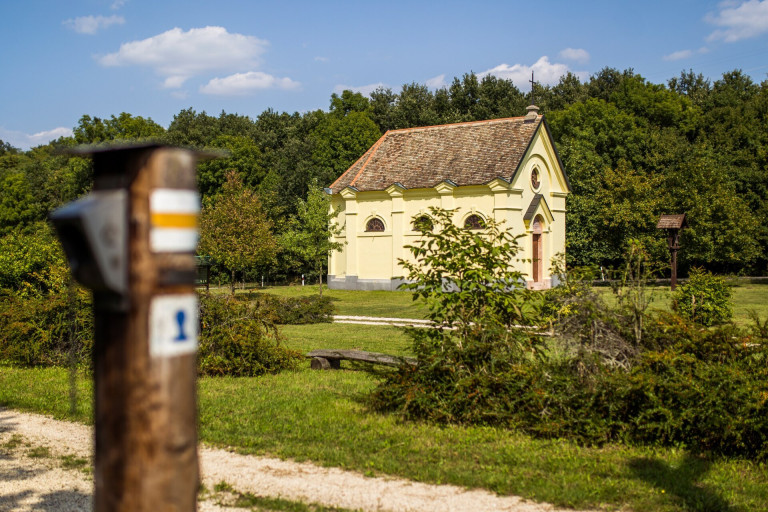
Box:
[370,209,541,425]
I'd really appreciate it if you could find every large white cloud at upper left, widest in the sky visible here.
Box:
[98,27,269,88]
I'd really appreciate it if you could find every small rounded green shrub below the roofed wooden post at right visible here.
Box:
[673,268,733,326]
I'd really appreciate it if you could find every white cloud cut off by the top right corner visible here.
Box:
[705,0,768,43]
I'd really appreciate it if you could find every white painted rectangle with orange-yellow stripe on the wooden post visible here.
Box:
[149,188,200,252]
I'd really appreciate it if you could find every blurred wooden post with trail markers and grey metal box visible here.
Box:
[51,145,200,512]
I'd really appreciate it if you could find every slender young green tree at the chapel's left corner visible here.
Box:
[282,187,343,296]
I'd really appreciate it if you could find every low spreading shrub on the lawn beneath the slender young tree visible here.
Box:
[248,293,334,325]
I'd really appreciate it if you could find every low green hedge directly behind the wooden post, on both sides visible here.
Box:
[0,288,302,376]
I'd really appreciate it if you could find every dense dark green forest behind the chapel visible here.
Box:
[0,68,768,288]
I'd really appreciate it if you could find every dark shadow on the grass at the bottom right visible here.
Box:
[629,454,739,512]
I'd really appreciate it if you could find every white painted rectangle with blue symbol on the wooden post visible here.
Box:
[149,293,199,357]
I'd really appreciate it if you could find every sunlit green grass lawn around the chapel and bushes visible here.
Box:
[0,285,768,512]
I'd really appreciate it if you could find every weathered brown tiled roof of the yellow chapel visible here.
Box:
[331,116,543,193]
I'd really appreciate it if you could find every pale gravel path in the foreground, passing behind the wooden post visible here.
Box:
[0,408,592,512]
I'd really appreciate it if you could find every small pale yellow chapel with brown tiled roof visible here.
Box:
[326,105,570,290]
